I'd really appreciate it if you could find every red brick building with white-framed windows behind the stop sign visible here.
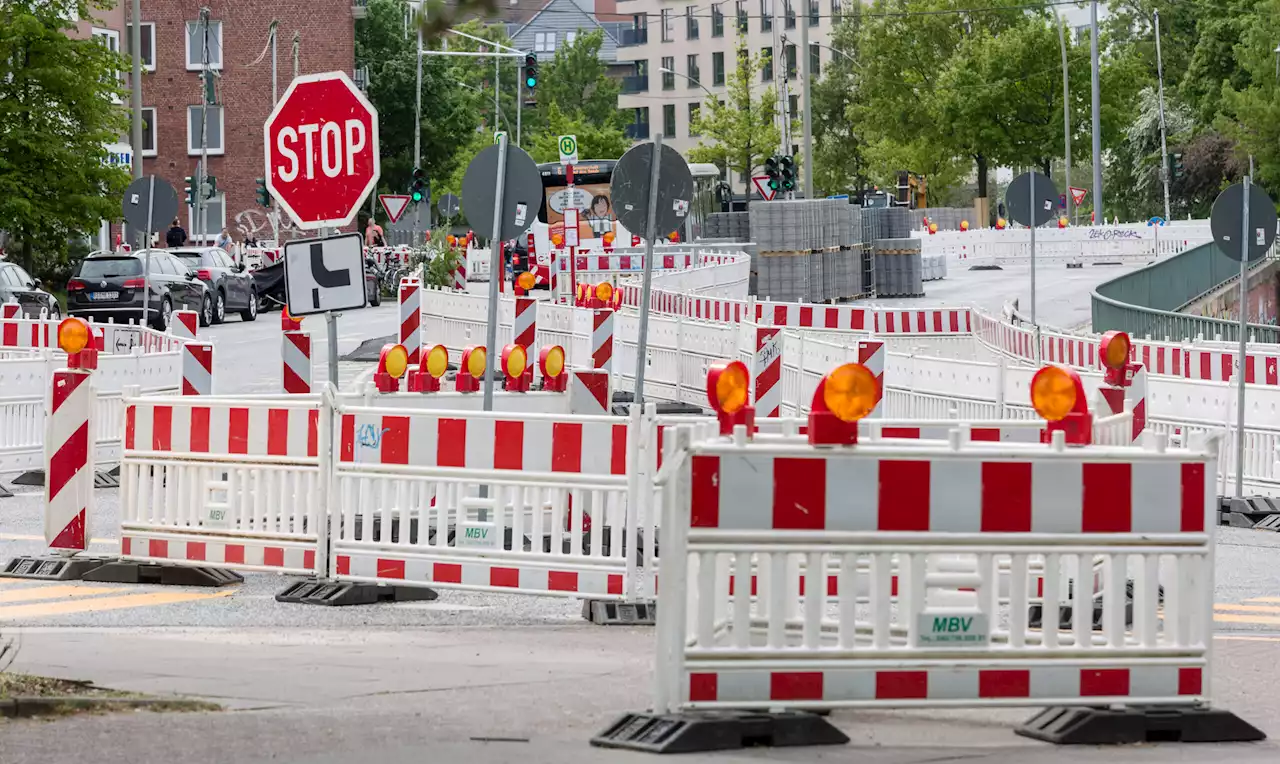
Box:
[122,0,362,243]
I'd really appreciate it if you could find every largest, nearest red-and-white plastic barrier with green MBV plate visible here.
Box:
[654,431,1216,713]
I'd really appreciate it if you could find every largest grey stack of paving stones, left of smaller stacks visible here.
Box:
[750,200,867,302]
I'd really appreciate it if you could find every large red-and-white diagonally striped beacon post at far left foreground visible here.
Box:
[45,369,95,552]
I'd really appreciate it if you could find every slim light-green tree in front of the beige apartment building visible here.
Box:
[689,42,782,200]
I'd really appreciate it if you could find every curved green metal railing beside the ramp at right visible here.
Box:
[1092,243,1280,343]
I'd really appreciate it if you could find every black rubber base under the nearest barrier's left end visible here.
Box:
[591,712,849,754]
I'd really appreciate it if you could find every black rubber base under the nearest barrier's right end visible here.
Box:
[1014,706,1267,745]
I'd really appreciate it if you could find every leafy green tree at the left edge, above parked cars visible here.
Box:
[0,0,129,271]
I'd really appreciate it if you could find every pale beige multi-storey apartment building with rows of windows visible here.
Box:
[618,0,852,188]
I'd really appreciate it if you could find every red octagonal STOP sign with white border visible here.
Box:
[262,72,380,229]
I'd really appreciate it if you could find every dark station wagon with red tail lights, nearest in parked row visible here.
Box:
[67,250,214,330]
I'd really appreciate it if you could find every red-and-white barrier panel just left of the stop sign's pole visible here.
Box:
[120,395,329,576]
